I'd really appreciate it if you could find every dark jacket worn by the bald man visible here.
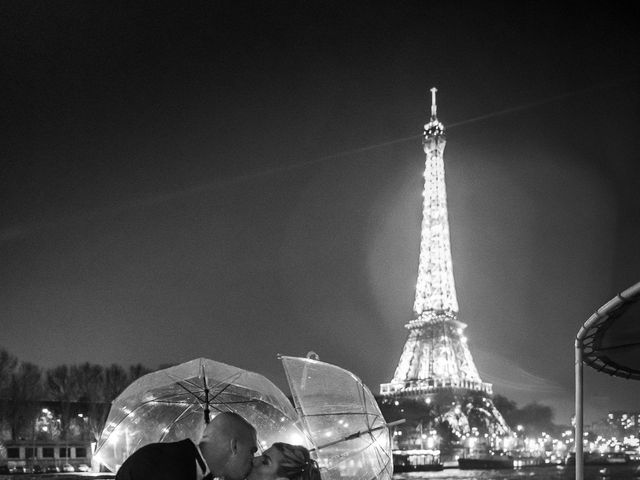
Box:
[116,439,203,480]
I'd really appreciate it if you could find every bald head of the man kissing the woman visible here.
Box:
[199,412,258,480]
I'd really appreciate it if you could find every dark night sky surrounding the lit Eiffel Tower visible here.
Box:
[0,0,640,423]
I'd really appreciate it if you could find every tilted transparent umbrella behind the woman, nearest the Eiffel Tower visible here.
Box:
[281,357,401,480]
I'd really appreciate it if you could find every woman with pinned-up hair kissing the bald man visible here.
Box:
[247,442,321,480]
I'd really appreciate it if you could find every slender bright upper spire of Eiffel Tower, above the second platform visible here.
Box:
[412,87,458,323]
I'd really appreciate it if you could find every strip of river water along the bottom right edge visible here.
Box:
[393,465,640,480]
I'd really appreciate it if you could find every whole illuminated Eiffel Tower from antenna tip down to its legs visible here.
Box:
[380,87,510,438]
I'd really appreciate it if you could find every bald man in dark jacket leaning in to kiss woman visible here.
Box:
[116,412,258,480]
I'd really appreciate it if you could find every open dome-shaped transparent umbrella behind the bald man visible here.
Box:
[94,358,308,471]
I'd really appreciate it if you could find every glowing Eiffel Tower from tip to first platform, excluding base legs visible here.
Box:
[380,88,492,396]
